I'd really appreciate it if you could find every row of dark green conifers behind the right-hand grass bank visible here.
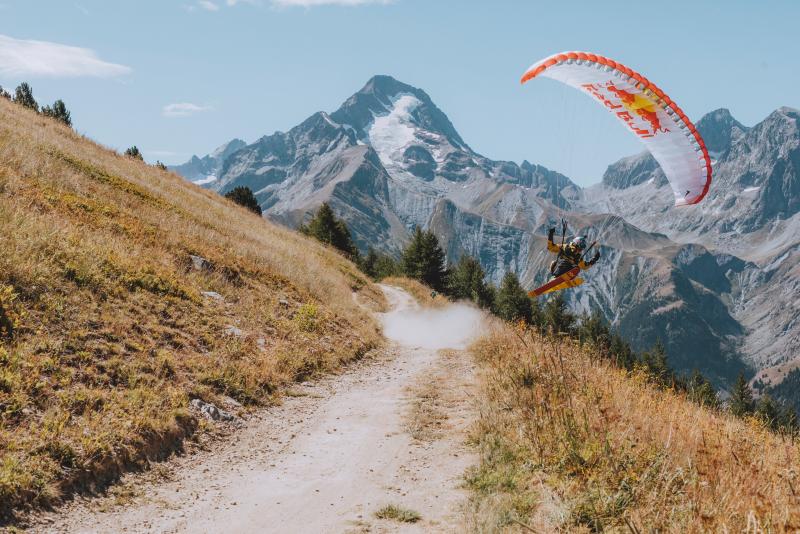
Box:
[300,203,800,436]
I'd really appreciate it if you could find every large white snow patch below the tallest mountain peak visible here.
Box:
[367,95,422,166]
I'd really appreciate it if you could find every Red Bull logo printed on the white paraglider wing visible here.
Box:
[581,81,669,138]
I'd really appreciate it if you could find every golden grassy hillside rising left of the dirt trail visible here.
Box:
[0,99,383,515]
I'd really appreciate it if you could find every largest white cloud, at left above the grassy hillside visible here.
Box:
[0,35,131,78]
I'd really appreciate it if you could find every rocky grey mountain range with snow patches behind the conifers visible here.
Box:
[170,76,800,394]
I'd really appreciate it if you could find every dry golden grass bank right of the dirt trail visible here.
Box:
[470,327,800,532]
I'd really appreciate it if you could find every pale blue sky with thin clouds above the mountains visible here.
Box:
[0,0,800,185]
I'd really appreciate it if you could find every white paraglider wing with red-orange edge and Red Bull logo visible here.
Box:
[521,52,711,206]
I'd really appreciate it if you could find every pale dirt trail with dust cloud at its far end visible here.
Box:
[33,286,482,533]
